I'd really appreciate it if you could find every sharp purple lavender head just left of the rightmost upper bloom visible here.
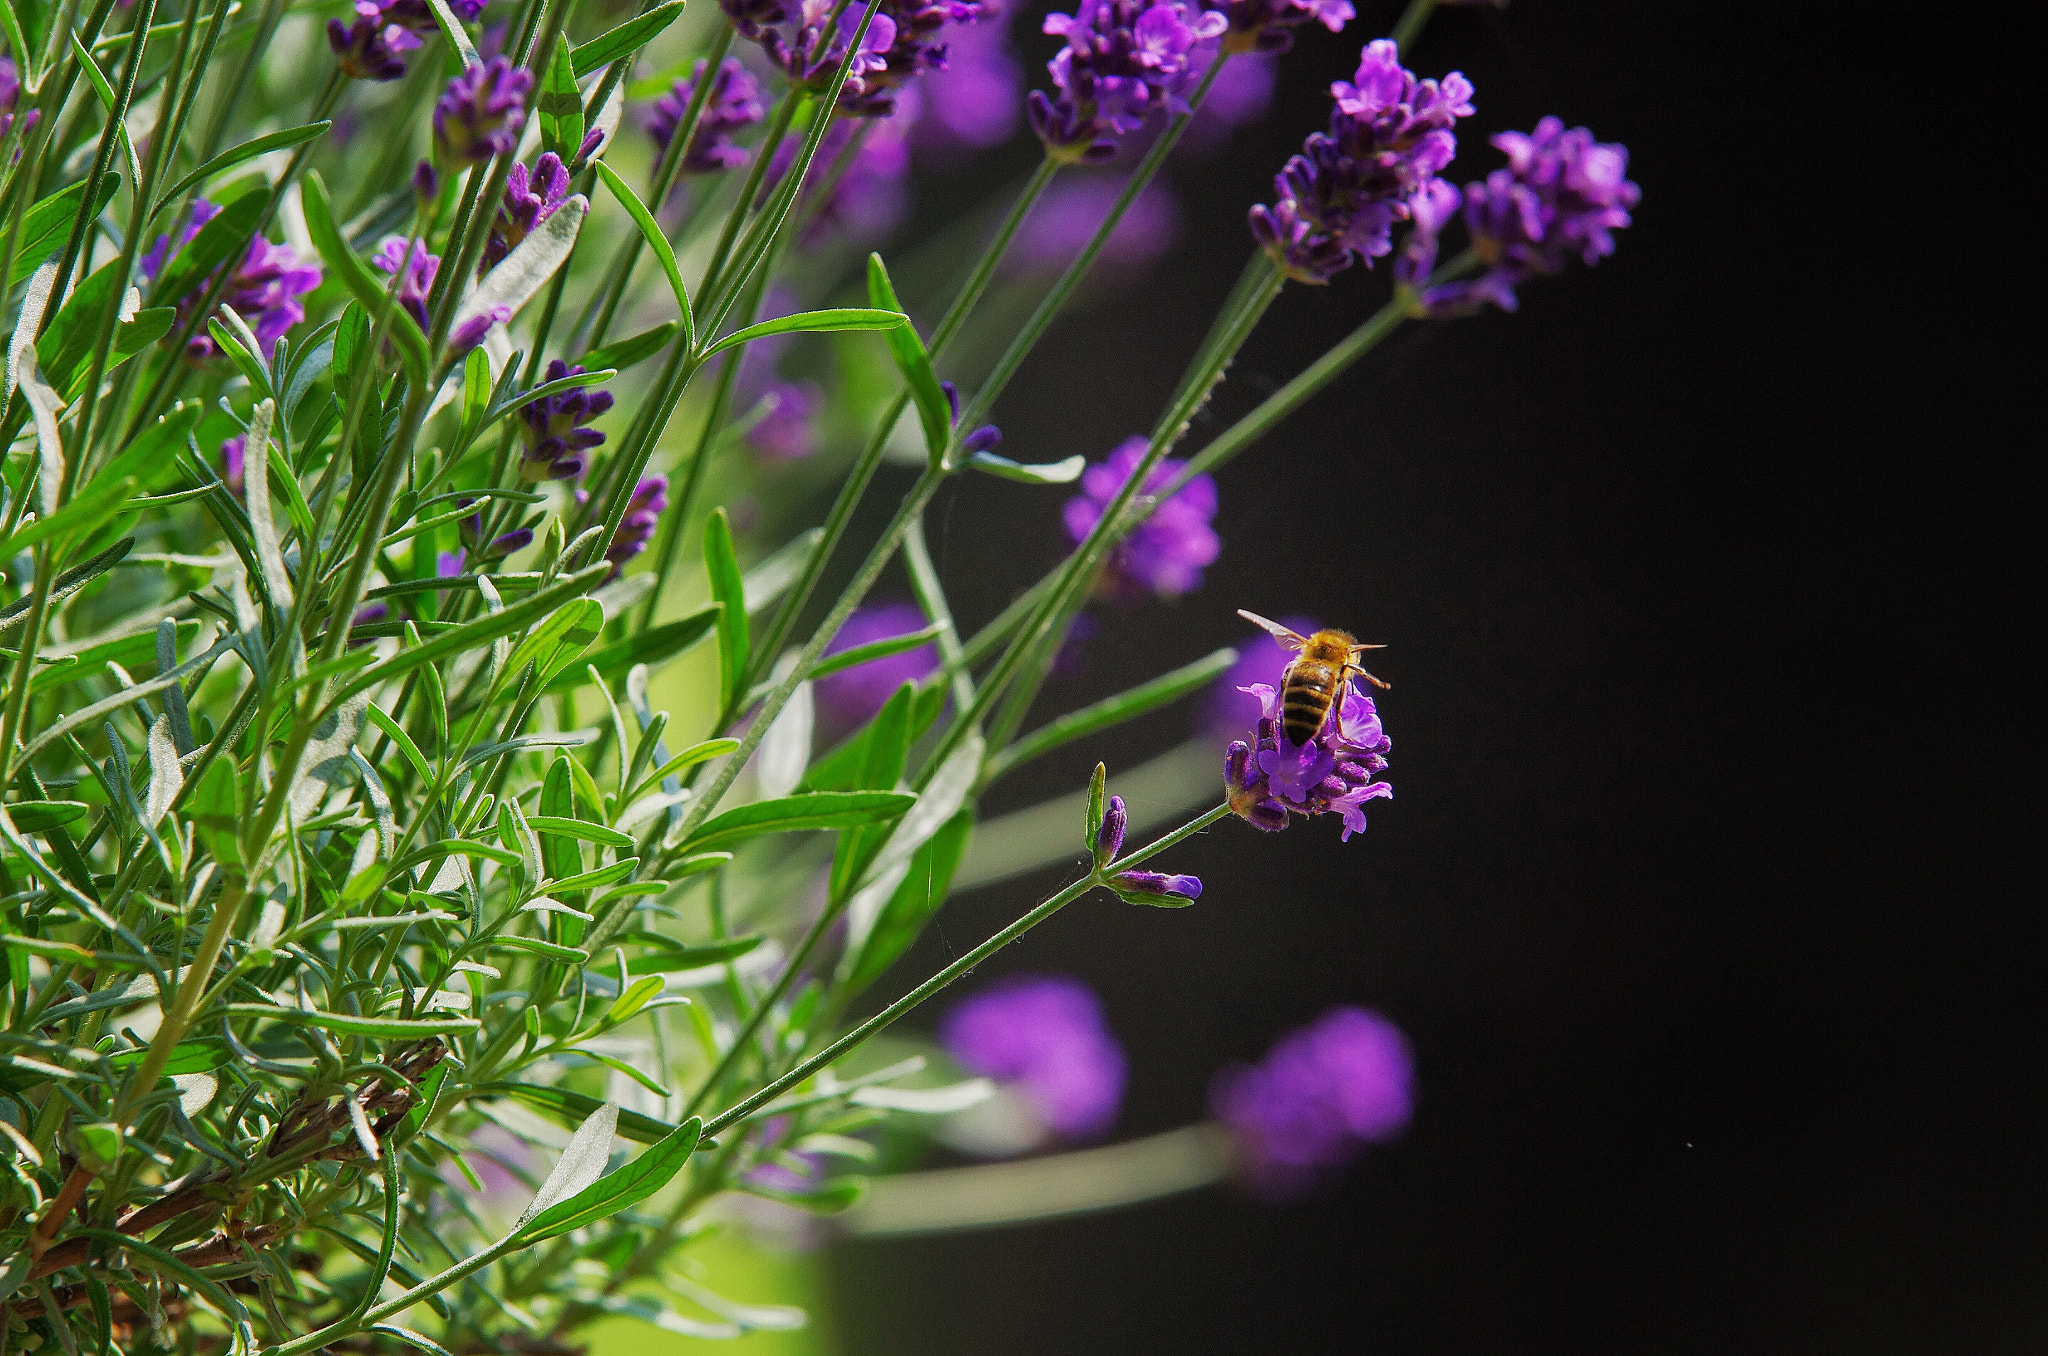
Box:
[1251,39,1473,283]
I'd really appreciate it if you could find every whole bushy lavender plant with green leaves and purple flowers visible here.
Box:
[0,0,1636,1356]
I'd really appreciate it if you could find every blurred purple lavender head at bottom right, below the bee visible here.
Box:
[1208,1008,1415,1200]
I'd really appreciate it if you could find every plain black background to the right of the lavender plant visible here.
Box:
[827,0,2048,1356]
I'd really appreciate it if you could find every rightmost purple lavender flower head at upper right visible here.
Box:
[1395,117,1642,317]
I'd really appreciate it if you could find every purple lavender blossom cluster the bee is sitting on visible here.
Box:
[1223,680,1395,842]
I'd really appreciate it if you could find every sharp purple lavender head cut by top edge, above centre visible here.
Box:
[1028,0,1229,162]
